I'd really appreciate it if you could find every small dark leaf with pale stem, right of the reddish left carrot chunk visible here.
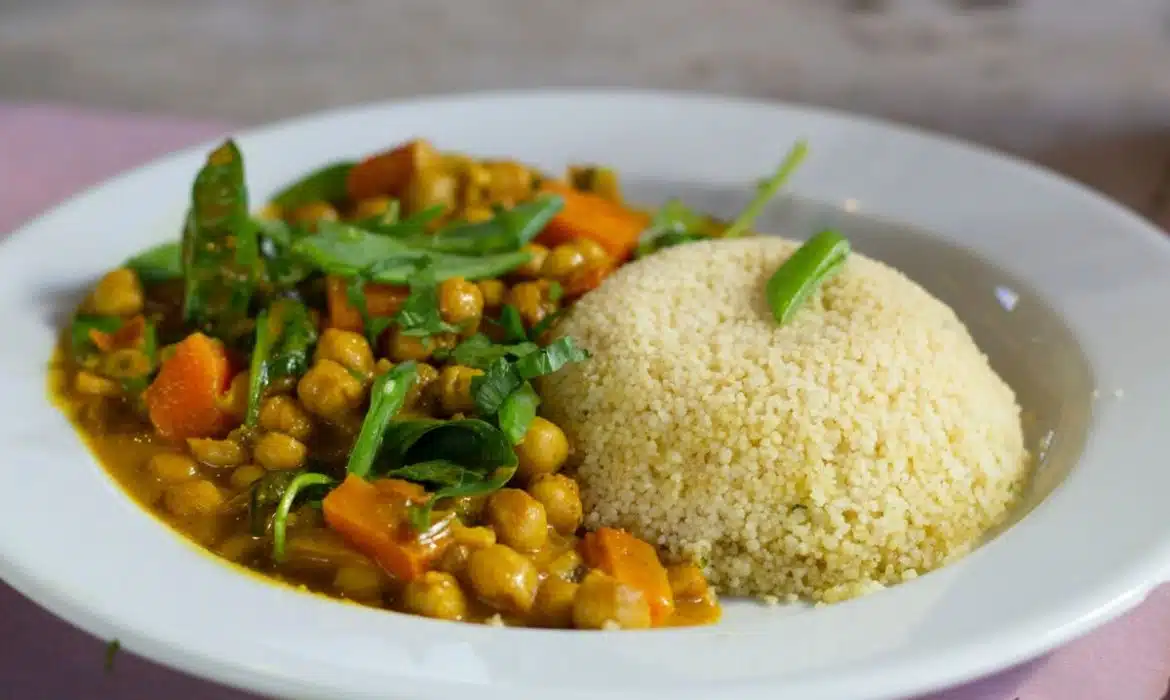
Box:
[245,298,317,426]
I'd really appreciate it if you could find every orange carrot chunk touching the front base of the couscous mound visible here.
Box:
[581,528,674,625]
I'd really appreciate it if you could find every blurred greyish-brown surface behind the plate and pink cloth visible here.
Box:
[0,0,1170,221]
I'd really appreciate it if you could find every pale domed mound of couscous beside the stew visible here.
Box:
[542,236,1028,602]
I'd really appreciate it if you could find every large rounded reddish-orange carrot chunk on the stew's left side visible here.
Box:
[143,332,233,439]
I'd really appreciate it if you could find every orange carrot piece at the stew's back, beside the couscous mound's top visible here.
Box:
[536,180,649,261]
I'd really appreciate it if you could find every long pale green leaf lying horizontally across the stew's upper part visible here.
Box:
[293,221,530,284]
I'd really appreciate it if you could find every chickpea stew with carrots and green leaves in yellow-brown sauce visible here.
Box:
[50,140,804,629]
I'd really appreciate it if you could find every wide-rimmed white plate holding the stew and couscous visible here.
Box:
[0,92,1170,700]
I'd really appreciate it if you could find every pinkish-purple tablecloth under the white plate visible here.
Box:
[0,100,1170,700]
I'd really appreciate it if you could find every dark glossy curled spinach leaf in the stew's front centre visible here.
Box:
[380,419,517,531]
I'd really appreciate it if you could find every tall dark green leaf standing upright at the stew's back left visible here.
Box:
[183,139,260,341]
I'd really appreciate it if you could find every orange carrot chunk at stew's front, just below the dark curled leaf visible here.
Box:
[322,474,450,581]
